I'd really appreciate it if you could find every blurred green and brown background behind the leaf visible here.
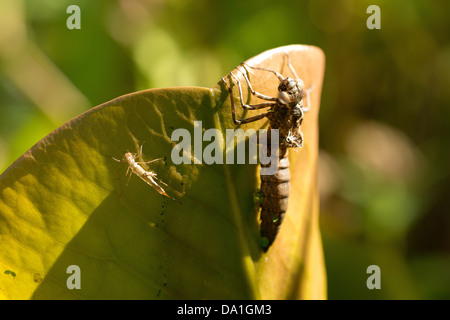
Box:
[0,0,450,299]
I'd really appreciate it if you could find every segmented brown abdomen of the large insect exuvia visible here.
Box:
[260,148,291,250]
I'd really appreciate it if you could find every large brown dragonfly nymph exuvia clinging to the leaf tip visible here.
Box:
[222,55,312,250]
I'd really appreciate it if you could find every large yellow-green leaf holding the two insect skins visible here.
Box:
[0,46,326,299]
